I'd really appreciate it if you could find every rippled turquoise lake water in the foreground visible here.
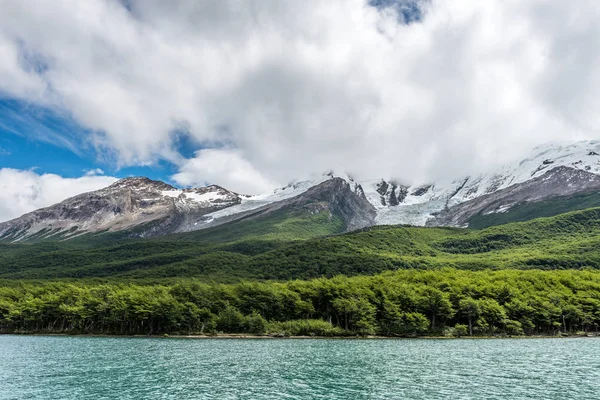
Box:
[0,336,600,400]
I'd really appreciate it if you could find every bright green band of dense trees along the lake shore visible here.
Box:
[0,269,600,336]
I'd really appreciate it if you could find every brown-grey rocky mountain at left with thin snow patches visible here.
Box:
[0,178,241,242]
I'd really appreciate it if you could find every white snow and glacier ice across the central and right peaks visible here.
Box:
[197,141,600,226]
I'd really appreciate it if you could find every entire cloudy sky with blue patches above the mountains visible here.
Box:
[0,0,600,220]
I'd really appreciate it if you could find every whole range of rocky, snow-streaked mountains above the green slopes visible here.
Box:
[0,141,600,241]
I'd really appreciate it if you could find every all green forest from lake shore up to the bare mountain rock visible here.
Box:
[0,208,600,336]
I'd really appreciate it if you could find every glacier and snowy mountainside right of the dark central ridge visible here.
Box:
[361,141,600,226]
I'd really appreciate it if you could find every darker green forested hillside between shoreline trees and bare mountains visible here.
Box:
[0,208,600,282]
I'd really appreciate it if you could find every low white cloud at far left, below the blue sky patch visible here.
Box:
[0,168,117,221]
